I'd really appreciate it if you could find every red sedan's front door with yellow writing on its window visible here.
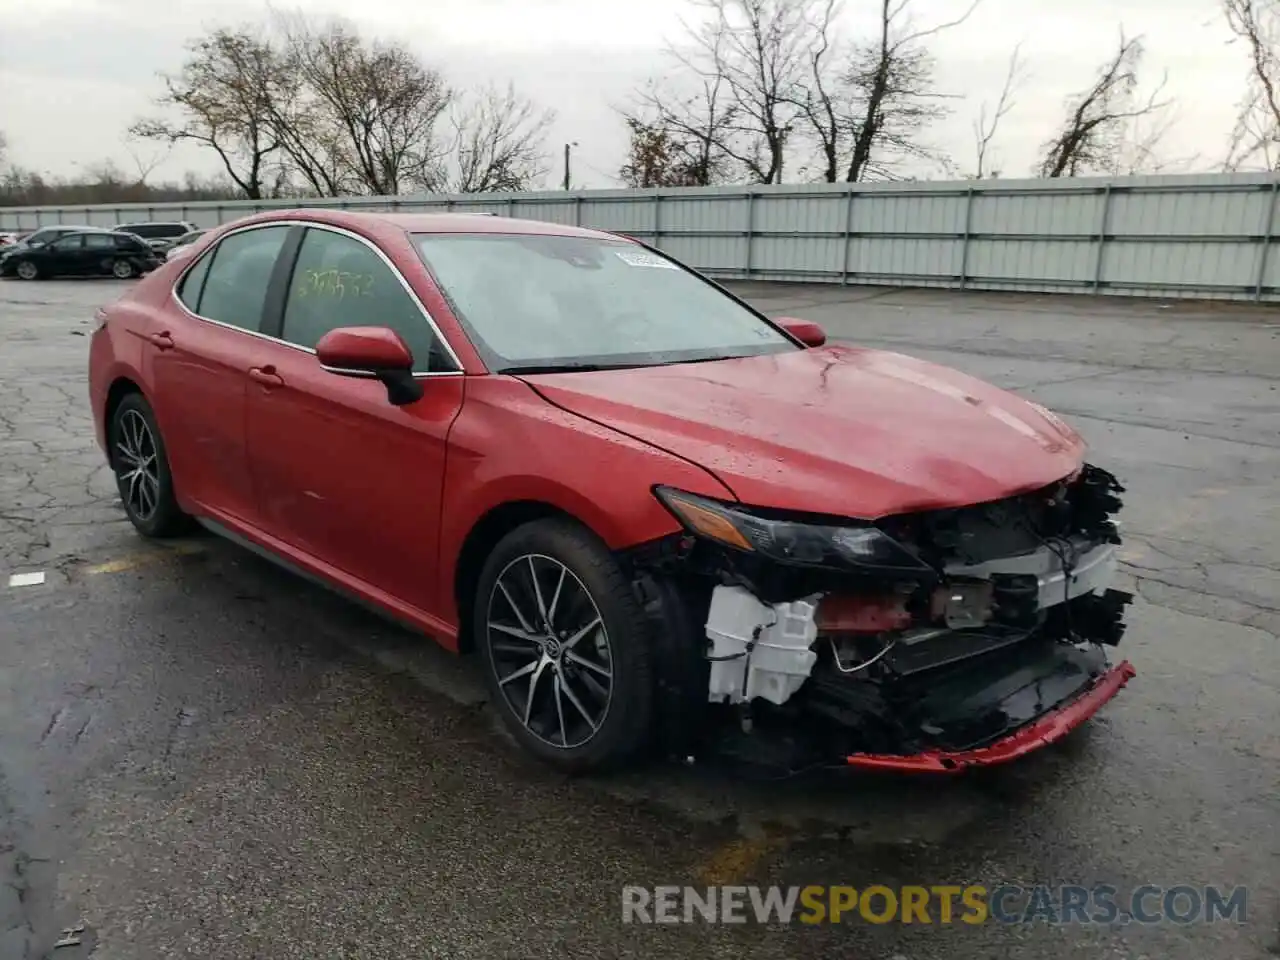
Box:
[247,225,463,614]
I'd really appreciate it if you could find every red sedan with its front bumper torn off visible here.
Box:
[90,211,1133,772]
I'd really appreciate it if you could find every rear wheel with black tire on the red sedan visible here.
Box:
[108,393,195,539]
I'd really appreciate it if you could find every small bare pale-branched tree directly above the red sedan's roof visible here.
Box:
[451,84,556,193]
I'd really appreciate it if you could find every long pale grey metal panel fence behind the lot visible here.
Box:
[0,174,1280,301]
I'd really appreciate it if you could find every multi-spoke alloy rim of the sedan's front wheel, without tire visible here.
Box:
[485,554,613,749]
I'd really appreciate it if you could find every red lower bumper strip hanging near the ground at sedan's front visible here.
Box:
[845,660,1138,773]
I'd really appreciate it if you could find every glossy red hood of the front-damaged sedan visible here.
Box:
[522,346,1084,518]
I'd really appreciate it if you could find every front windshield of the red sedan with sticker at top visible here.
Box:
[413,233,799,372]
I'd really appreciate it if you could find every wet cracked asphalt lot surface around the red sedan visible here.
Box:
[0,273,1280,960]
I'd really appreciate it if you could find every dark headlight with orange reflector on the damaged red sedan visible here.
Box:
[654,486,933,573]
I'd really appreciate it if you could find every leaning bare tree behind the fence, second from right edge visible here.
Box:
[1039,32,1171,177]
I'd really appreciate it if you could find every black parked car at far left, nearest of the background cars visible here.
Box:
[0,229,163,280]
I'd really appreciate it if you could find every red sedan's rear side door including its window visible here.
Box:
[147,224,298,526]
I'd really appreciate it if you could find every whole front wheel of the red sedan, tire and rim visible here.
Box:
[472,520,653,773]
